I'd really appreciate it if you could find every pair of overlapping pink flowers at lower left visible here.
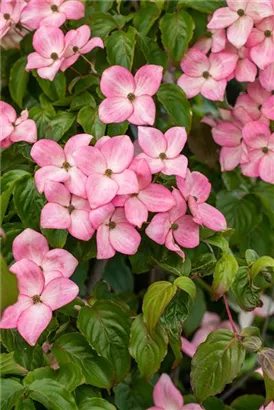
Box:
[0,229,79,345]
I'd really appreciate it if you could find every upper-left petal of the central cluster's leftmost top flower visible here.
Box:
[30,139,66,167]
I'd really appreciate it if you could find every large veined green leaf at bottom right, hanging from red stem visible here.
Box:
[190,330,245,402]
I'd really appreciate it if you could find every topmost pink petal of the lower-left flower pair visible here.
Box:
[12,228,49,265]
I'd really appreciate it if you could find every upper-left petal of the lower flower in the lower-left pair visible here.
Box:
[10,259,45,297]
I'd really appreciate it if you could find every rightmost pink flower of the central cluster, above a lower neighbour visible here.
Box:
[176,170,227,231]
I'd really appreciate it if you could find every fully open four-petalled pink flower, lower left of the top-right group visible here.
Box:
[178,48,238,101]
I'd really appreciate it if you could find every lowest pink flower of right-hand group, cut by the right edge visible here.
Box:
[242,121,274,184]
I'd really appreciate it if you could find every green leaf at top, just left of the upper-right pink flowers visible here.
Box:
[160,10,194,62]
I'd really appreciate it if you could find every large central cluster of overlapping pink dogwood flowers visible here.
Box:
[31,127,226,259]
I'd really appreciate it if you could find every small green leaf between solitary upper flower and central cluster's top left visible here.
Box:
[77,107,106,140]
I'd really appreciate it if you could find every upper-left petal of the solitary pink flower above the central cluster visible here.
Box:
[100,65,135,97]
